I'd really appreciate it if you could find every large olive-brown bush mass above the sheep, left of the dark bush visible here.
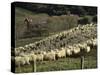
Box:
[47,15,78,32]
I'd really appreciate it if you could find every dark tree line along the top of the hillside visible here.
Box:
[15,2,97,16]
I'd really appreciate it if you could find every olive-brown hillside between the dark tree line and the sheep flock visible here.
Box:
[15,7,77,47]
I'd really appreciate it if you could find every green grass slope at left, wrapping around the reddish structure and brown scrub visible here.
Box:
[15,7,48,47]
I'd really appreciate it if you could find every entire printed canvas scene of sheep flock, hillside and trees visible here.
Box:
[11,2,98,73]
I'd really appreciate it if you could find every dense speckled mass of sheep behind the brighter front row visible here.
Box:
[15,24,97,53]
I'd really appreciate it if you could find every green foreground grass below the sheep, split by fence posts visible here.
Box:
[16,47,97,73]
